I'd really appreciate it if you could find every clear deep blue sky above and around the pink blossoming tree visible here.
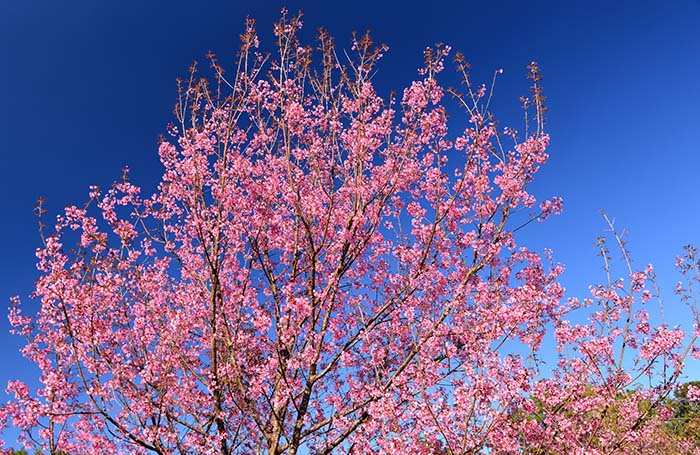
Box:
[0,0,700,448]
